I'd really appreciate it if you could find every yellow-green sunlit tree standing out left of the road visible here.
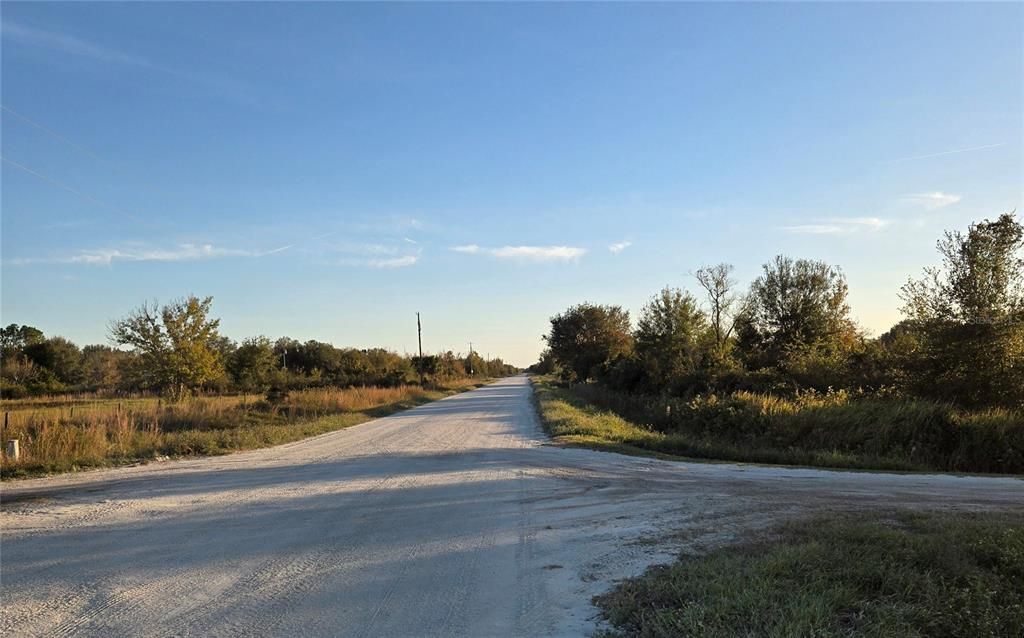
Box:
[111,296,223,398]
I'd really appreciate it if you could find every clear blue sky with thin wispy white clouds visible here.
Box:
[2,2,1024,365]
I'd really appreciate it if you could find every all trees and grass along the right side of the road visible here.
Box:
[530,214,1024,473]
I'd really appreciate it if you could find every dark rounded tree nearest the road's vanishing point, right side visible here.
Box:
[545,303,633,381]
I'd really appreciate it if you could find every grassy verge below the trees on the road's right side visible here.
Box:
[532,377,1024,473]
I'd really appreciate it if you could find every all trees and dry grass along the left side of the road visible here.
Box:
[0,297,518,477]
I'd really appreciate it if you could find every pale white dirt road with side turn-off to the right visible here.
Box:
[0,377,1024,638]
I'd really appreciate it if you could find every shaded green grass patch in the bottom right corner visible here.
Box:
[595,512,1024,638]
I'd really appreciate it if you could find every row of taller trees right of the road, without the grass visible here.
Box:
[530,213,1024,408]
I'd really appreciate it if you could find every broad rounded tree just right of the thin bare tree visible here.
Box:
[736,255,856,367]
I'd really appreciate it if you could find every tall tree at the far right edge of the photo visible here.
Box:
[901,214,1024,407]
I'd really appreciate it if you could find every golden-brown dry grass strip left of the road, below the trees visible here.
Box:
[0,379,491,478]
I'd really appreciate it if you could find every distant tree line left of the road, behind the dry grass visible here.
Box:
[0,296,518,398]
